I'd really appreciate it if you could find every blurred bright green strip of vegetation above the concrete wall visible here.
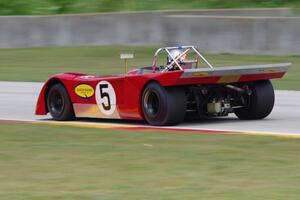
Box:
[0,0,300,15]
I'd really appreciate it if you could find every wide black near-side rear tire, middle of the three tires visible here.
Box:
[141,82,186,126]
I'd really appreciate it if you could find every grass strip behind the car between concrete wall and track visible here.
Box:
[0,46,300,90]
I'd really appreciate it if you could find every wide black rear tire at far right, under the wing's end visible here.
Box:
[234,80,275,120]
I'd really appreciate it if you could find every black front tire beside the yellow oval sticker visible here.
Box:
[46,83,75,121]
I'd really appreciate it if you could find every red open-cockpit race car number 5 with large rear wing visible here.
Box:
[36,46,291,125]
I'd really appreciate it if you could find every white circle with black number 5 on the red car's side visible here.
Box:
[96,81,116,115]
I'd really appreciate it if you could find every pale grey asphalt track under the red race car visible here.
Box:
[0,81,300,136]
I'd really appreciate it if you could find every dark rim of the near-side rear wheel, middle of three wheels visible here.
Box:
[144,90,160,117]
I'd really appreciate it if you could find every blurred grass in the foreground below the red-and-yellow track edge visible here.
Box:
[0,123,300,200]
